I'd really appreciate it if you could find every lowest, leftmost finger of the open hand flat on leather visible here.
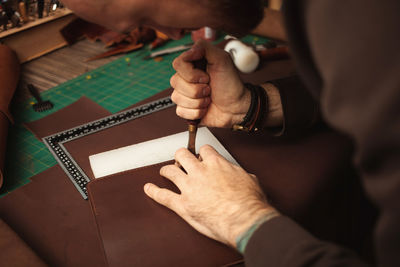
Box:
[144,183,180,213]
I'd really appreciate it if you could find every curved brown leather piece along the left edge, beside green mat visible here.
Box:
[0,44,20,187]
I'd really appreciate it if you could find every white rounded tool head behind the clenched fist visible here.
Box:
[224,39,260,73]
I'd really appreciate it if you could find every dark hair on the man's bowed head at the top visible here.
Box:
[209,0,264,35]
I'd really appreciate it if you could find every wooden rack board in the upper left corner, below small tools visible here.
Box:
[0,9,76,63]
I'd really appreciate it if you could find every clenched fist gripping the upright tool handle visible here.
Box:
[170,41,250,128]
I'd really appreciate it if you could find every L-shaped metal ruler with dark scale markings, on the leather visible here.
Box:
[43,97,175,199]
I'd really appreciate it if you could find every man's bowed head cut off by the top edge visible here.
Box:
[63,0,263,39]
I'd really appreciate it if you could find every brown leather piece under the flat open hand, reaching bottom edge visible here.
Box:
[88,162,241,267]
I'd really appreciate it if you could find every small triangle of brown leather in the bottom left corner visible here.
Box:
[0,219,47,267]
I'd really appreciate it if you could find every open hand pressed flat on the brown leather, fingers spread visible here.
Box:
[144,145,274,247]
